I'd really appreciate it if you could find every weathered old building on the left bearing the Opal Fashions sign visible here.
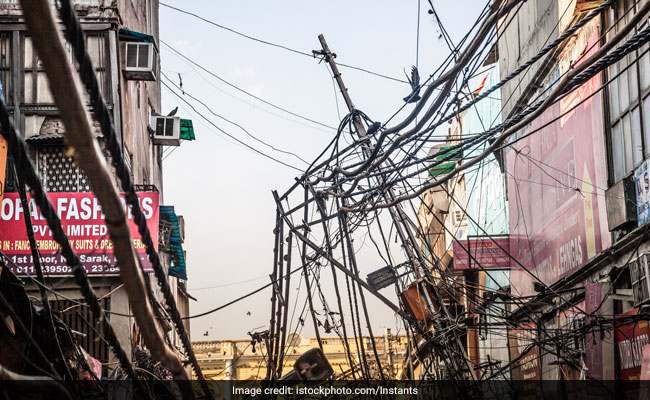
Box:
[0,0,189,376]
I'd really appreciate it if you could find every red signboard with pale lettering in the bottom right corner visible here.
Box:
[616,309,650,381]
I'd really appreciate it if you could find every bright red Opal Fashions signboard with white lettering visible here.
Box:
[0,192,159,275]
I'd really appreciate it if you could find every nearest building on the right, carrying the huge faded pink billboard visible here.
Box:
[498,0,650,388]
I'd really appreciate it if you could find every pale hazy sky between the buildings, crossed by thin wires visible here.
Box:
[160,0,486,341]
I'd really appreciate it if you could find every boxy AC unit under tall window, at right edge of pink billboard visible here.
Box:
[605,177,637,231]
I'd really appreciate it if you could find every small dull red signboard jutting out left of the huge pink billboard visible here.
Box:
[453,238,510,269]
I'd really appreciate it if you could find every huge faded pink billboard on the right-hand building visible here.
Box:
[506,33,611,296]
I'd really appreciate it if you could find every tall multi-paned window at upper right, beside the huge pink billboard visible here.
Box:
[607,0,650,182]
